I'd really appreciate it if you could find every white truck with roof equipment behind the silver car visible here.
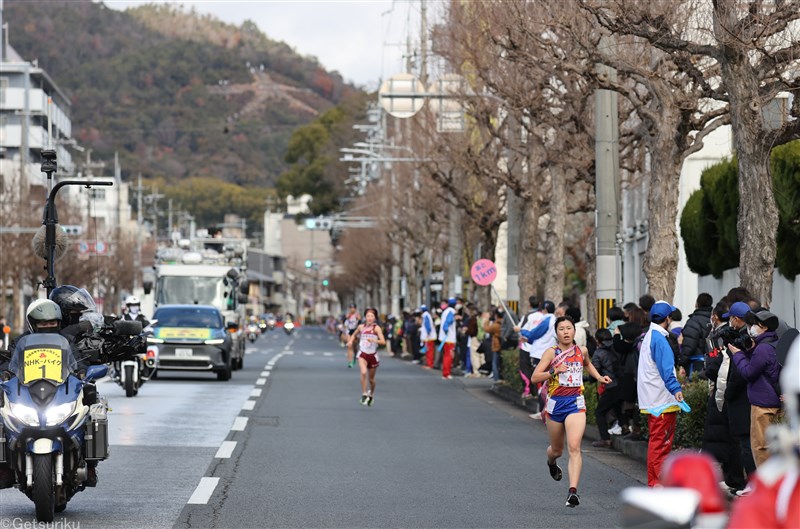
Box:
[144,237,249,370]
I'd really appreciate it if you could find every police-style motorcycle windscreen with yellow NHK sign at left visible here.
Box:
[9,333,77,386]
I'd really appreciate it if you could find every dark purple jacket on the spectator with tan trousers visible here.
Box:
[732,331,781,408]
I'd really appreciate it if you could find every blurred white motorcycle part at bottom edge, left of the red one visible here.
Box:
[620,487,701,529]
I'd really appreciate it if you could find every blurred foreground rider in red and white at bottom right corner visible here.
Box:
[728,337,800,529]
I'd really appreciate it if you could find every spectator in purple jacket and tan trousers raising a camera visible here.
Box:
[728,310,781,467]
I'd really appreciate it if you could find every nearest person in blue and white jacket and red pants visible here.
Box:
[636,301,683,487]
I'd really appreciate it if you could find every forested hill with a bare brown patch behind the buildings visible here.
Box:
[3,0,355,187]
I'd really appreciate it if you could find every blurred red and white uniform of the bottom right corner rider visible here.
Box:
[728,456,800,529]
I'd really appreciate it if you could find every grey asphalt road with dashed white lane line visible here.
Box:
[0,328,645,529]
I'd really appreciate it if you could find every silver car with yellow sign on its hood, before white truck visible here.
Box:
[147,305,238,380]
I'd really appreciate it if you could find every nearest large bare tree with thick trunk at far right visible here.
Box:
[580,0,800,303]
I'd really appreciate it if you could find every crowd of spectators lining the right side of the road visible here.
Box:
[339,288,798,496]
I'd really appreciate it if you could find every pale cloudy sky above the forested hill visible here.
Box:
[111,0,432,89]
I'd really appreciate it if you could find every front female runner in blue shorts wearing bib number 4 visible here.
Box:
[531,316,611,507]
